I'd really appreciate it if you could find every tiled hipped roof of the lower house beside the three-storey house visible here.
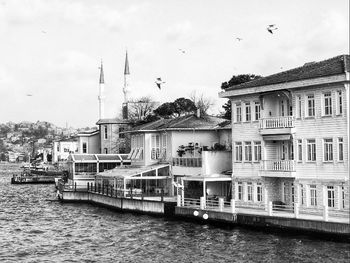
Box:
[127,114,224,132]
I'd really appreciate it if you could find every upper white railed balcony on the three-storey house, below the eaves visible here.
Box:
[259,116,295,135]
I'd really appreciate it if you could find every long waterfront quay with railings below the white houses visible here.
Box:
[58,184,350,241]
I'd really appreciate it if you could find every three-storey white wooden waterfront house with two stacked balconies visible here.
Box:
[220,55,350,218]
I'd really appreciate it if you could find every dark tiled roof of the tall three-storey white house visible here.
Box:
[225,55,350,91]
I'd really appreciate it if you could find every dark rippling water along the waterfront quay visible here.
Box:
[0,164,350,262]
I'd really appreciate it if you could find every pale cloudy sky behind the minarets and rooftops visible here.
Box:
[0,0,349,128]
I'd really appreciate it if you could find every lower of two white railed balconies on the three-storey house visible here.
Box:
[259,160,295,177]
